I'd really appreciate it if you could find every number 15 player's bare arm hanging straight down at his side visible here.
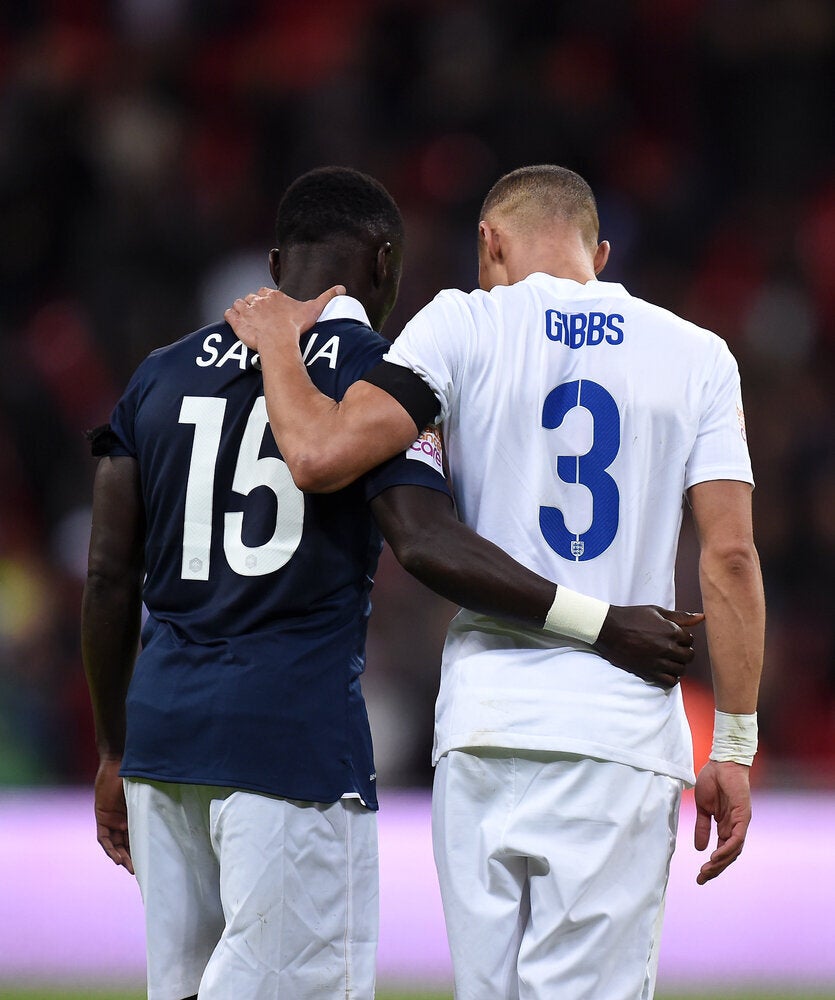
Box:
[81,457,145,873]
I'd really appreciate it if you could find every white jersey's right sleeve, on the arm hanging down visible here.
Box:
[684,338,754,489]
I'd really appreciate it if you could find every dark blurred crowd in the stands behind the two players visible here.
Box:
[0,0,835,786]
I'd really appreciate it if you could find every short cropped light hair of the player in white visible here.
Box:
[480,163,600,249]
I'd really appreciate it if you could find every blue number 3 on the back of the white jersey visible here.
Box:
[539,379,620,562]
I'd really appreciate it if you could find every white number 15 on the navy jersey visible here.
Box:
[179,396,304,580]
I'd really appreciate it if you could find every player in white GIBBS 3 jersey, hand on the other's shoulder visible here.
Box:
[226,165,765,1000]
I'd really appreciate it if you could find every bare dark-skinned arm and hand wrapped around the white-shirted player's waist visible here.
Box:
[371,486,703,688]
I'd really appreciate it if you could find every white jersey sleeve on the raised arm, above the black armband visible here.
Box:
[385,290,474,423]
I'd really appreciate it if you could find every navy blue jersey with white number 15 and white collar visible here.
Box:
[110,297,454,807]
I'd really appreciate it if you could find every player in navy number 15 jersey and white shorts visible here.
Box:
[82,168,700,1000]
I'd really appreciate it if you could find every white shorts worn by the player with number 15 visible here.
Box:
[125,779,379,1000]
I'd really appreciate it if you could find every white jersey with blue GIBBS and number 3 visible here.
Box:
[386,273,753,781]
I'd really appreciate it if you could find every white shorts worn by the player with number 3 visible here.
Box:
[432,749,682,1000]
